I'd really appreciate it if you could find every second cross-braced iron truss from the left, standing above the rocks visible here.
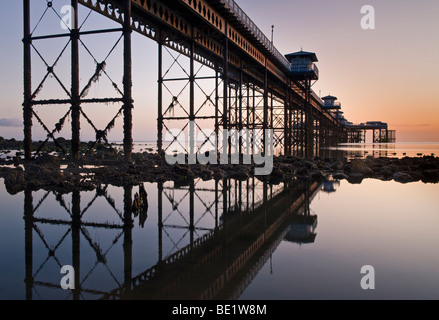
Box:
[157,36,223,154]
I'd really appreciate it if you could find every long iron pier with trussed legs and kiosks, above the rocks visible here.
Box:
[23,0,396,162]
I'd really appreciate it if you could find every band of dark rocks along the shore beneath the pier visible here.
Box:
[0,143,439,194]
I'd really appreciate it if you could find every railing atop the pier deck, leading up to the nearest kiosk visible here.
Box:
[219,0,291,70]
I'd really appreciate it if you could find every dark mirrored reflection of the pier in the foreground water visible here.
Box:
[18,179,319,299]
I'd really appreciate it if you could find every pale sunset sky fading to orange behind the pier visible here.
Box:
[0,0,439,142]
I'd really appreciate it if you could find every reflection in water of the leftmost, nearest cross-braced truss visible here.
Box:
[24,186,133,299]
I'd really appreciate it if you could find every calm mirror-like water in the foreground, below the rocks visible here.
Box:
[0,174,439,300]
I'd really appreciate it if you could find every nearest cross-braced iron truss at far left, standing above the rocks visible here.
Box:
[23,0,133,161]
